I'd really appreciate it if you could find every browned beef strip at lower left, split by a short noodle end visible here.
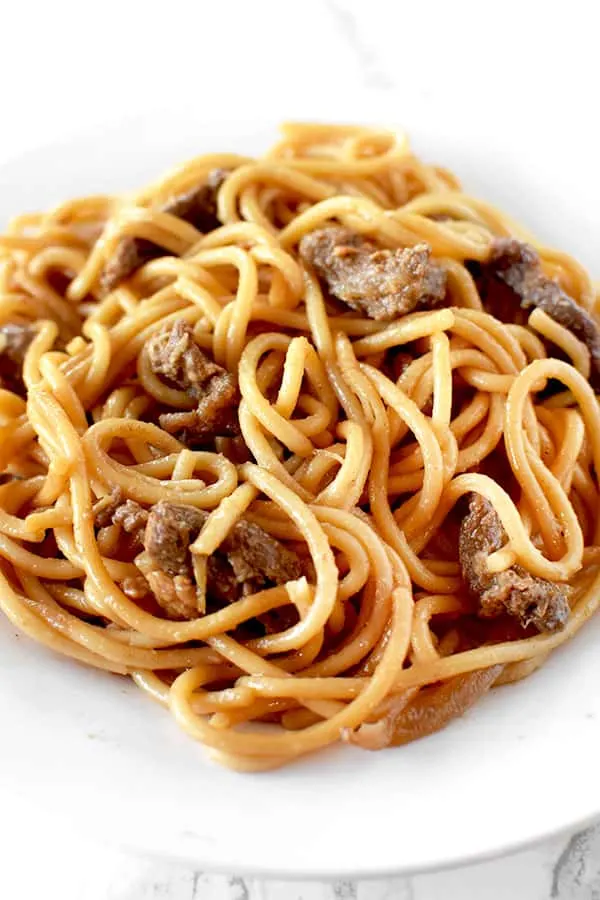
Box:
[141,501,302,619]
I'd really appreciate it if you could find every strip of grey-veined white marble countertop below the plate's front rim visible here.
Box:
[0,816,600,900]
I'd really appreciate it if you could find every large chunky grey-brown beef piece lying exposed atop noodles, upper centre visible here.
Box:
[299,225,446,320]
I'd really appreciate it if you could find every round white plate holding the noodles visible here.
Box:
[0,103,600,878]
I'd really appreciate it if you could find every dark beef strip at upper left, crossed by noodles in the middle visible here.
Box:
[100,169,228,293]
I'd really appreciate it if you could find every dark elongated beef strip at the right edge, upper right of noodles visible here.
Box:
[483,238,600,387]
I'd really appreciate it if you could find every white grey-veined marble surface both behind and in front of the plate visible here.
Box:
[0,0,600,900]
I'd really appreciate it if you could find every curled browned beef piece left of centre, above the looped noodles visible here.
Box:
[147,319,239,446]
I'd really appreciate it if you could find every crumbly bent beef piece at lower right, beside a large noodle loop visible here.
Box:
[459,494,569,632]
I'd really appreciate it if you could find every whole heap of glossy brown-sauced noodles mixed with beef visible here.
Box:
[0,116,600,771]
